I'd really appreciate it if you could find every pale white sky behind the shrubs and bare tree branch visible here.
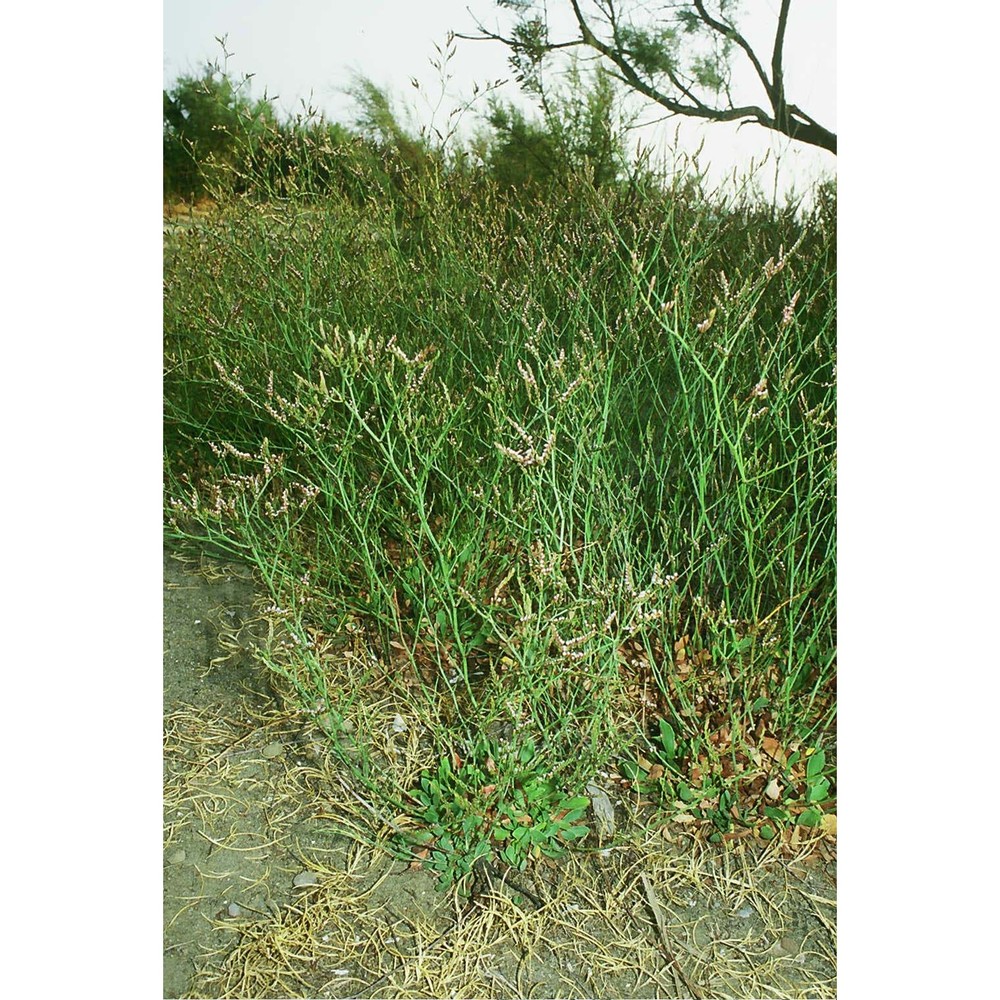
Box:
[163,0,837,203]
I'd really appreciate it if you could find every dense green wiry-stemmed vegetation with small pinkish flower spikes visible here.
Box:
[164,56,836,884]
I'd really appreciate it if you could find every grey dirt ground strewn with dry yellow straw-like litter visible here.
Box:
[163,553,836,1000]
